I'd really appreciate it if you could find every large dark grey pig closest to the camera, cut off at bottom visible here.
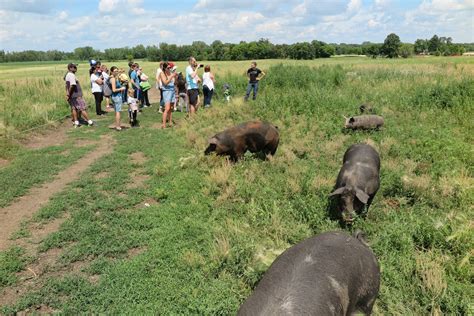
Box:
[238,232,380,316]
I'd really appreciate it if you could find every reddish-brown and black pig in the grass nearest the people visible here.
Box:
[204,121,280,161]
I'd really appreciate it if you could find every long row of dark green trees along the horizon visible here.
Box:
[0,33,474,63]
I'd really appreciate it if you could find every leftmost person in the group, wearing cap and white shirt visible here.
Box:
[64,63,94,127]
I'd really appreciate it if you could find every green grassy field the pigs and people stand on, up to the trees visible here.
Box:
[0,57,474,315]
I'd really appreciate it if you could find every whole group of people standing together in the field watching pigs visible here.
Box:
[64,57,265,131]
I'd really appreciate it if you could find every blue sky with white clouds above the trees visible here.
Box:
[0,0,474,51]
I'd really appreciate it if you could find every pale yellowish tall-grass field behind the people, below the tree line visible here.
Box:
[0,57,474,138]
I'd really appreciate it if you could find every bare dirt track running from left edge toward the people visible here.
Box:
[0,135,113,251]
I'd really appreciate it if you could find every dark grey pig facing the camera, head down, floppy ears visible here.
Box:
[329,144,380,223]
